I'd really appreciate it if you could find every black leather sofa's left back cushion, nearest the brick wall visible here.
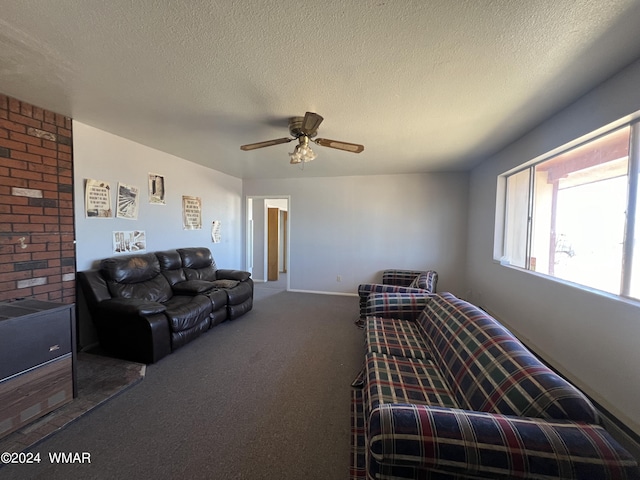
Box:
[100,253,172,302]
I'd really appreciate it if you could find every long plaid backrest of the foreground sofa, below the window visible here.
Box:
[418,294,599,423]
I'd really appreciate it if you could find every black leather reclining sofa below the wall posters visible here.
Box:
[78,248,253,363]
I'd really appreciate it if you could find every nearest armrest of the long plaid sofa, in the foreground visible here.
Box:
[367,404,640,479]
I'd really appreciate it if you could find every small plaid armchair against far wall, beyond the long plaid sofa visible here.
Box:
[358,269,438,319]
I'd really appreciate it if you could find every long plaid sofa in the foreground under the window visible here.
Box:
[351,293,640,480]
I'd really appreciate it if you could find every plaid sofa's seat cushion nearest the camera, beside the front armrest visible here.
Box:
[365,352,458,415]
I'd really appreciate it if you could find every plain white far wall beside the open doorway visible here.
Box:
[244,173,468,294]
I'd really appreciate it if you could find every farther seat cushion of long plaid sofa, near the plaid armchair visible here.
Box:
[364,317,431,360]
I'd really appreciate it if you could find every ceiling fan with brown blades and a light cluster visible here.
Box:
[240,112,364,164]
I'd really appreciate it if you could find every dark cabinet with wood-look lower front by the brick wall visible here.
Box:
[0,299,77,437]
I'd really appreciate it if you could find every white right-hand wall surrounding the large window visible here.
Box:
[468,58,640,434]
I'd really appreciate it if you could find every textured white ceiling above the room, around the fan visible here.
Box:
[0,0,640,178]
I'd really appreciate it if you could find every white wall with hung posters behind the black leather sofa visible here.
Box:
[73,121,244,270]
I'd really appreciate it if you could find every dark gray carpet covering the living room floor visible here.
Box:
[0,284,363,480]
